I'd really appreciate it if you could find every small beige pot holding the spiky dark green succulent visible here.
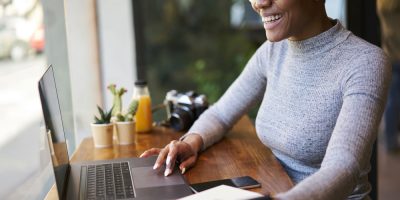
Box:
[91,124,113,148]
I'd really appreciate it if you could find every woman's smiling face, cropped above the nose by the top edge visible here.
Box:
[250,0,323,42]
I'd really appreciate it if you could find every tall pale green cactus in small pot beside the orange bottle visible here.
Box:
[107,84,138,145]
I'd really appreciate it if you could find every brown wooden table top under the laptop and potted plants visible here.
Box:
[47,116,293,198]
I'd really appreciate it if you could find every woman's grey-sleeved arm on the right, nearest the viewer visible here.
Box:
[276,50,391,200]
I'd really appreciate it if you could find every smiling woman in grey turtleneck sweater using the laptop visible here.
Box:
[142,0,391,200]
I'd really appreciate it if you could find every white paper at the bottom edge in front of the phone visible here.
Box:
[179,185,262,200]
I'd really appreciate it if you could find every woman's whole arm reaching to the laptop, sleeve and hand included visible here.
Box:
[140,44,266,176]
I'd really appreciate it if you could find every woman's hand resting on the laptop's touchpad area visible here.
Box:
[140,134,203,176]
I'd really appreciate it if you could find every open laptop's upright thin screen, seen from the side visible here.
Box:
[39,66,69,198]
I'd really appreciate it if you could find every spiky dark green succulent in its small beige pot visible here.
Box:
[91,106,113,148]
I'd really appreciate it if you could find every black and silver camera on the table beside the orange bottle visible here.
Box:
[164,90,208,131]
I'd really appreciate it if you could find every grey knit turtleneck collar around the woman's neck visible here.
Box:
[286,20,350,55]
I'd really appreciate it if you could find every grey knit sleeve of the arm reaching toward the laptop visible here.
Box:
[181,43,267,150]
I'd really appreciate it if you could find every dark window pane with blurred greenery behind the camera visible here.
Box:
[141,0,265,121]
